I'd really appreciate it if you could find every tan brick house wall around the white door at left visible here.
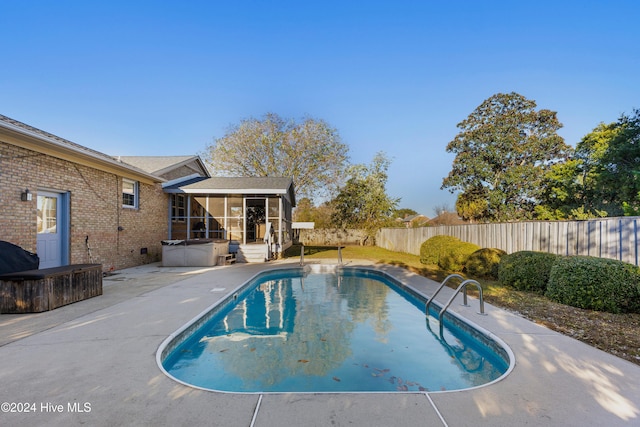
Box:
[0,141,168,271]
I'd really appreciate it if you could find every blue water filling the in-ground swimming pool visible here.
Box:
[161,268,509,392]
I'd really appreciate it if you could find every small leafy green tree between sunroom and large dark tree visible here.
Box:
[332,152,400,239]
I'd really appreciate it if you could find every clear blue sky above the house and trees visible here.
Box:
[0,0,640,217]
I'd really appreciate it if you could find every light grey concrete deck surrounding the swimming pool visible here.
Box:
[0,262,640,427]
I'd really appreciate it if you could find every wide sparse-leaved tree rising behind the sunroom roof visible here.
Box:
[205,113,349,198]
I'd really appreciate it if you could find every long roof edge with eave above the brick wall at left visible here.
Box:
[0,114,164,183]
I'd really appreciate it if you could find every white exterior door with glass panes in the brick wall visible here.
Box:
[36,191,63,268]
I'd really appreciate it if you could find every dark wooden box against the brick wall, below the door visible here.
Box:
[0,264,102,313]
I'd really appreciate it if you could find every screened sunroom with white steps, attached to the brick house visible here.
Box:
[163,176,295,262]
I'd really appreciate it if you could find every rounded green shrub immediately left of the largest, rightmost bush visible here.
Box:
[498,251,560,294]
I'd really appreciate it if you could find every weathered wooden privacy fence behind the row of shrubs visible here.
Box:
[376,217,640,265]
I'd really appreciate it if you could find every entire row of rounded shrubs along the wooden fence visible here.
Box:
[420,236,640,313]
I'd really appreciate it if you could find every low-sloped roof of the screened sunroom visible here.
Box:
[164,176,296,206]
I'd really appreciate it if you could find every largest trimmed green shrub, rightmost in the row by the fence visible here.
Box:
[546,256,640,313]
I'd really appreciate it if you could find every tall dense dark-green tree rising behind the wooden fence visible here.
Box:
[442,92,571,221]
